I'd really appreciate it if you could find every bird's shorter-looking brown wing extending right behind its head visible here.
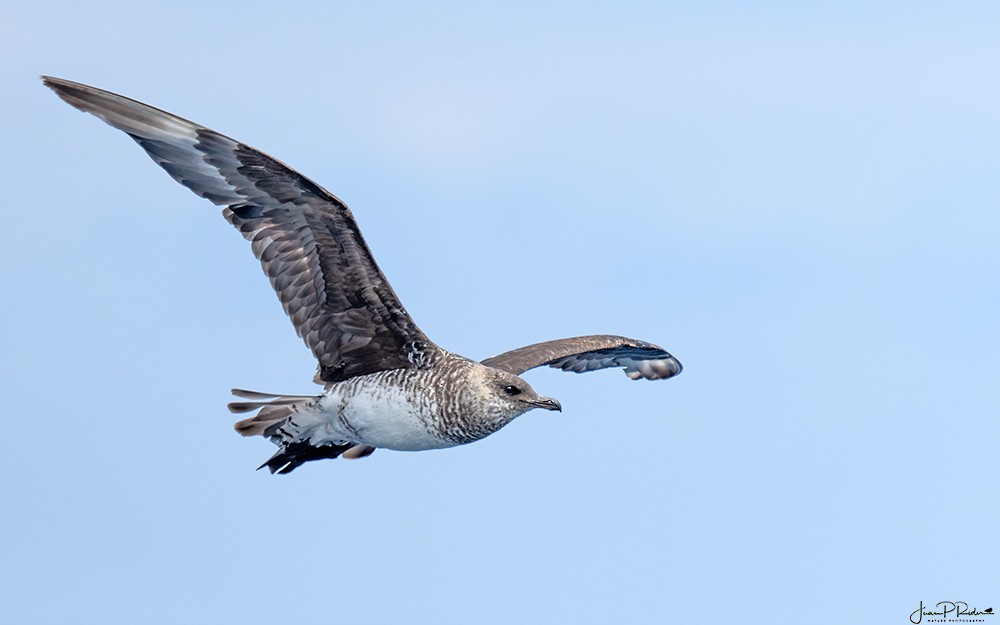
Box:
[482,334,683,380]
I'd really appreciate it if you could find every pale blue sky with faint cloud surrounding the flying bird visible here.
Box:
[0,1,1000,624]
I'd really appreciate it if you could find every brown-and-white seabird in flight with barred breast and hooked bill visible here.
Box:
[41,76,682,474]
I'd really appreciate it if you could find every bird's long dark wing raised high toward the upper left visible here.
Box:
[43,77,438,383]
